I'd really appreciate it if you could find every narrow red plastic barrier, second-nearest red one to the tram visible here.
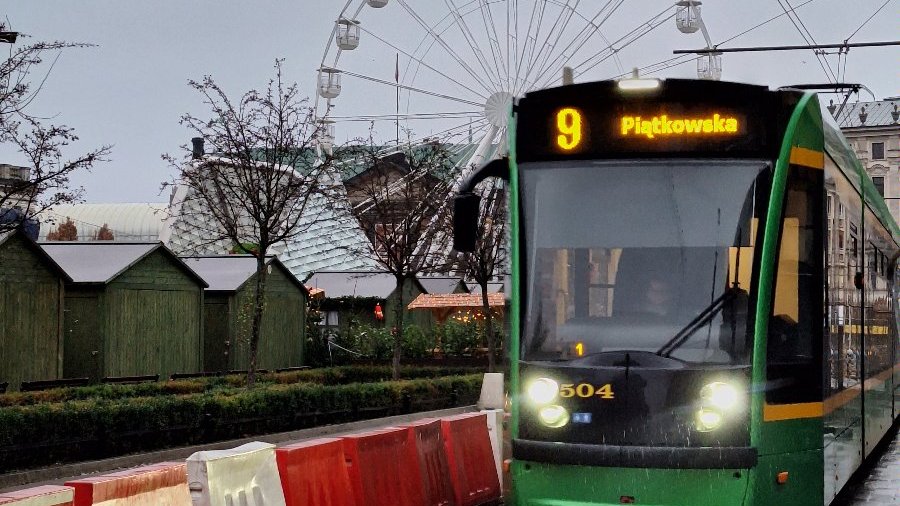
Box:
[403,418,456,506]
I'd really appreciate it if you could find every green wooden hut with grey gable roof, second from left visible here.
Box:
[41,241,206,381]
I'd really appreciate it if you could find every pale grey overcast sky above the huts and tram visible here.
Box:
[0,0,900,202]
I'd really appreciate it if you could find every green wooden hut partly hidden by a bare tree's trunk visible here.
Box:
[182,255,308,371]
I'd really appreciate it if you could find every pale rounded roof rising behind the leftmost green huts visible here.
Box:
[38,203,167,242]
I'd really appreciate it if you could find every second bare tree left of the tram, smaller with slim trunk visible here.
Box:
[344,137,457,379]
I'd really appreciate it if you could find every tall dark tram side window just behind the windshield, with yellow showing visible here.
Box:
[766,166,824,403]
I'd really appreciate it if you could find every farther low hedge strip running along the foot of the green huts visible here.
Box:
[0,366,476,407]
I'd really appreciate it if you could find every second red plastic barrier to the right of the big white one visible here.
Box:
[342,428,425,506]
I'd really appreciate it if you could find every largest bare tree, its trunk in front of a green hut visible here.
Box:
[164,60,331,386]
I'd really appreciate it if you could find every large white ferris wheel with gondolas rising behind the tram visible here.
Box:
[315,0,721,173]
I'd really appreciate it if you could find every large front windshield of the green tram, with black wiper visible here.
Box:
[520,160,770,367]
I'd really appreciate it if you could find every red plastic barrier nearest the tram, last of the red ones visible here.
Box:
[441,413,500,506]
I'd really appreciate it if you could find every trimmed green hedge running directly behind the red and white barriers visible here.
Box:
[0,374,482,472]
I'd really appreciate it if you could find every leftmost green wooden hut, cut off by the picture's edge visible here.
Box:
[0,231,71,390]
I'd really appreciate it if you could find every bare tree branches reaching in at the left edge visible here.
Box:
[0,24,110,232]
